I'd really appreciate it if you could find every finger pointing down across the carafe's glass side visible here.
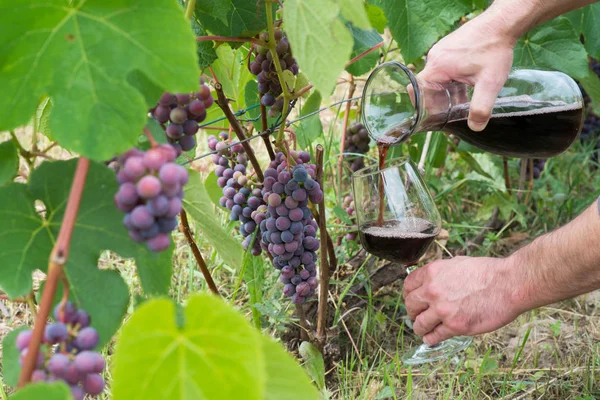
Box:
[468,73,504,132]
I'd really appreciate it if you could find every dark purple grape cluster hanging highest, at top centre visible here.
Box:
[249,28,298,117]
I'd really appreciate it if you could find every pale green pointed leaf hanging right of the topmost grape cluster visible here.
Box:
[284,0,353,95]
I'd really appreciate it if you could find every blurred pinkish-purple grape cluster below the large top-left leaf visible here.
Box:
[114,144,189,252]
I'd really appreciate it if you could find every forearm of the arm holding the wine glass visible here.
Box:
[507,202,600,312]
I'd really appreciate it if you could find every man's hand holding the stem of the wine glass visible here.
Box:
[402,257,524,345]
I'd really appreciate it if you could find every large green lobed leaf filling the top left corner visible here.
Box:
[0,0,199,160]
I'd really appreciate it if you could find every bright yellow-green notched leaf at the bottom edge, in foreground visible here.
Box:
[112,294,266,400]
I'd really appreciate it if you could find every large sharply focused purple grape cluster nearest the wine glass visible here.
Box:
[254,151,323,304]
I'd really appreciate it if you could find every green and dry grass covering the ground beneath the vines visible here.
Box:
[0,120,600,400]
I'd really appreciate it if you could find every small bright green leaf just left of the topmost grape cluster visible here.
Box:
[212,44,252,110]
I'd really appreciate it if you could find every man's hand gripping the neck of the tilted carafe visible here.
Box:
[418,13,517,131]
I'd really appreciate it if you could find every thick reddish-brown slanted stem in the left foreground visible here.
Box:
[18,157,90,388]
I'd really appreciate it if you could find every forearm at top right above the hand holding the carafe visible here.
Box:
[480,0,599,41]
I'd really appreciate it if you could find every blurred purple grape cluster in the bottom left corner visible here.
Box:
[16,302,105,400]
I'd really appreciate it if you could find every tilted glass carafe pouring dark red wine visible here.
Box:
[362,61,584,158]
